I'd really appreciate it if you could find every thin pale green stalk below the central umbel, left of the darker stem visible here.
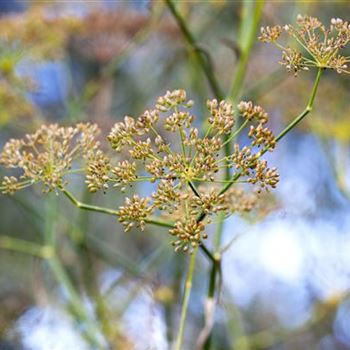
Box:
[175,249,197,350]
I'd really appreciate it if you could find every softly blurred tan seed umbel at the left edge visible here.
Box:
[0,124,103,193]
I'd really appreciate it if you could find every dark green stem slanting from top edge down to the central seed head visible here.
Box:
[164,0,224,100]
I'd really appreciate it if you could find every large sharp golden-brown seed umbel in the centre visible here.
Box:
[104,90,278,252]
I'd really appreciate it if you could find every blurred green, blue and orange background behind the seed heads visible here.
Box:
[0,0,350,350]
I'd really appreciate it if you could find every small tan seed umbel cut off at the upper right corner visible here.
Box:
[259,15,350,75]
